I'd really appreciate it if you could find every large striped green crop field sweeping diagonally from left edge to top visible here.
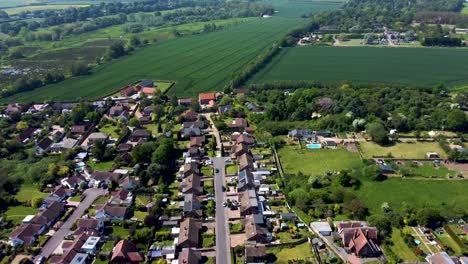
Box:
[3,1,340,102]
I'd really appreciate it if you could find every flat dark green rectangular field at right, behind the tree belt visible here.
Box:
[250,46,468,86]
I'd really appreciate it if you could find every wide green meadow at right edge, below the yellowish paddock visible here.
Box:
[356,178,468,216]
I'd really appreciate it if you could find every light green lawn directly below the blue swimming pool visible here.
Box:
[278,145,362,175]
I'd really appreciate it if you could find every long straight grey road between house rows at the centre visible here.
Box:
[204,114,231,264]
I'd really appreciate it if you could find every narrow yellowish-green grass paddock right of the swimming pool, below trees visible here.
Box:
[359,142,447,159]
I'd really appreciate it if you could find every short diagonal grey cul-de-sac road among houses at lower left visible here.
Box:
[40,188,105,258]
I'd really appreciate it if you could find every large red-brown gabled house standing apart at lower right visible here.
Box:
[339,224,382,257]
